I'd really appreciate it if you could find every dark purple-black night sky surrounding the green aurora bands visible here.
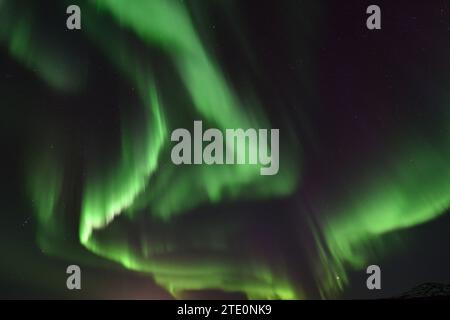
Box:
[0,0,450,298]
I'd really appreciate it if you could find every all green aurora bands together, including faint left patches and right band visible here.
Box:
[2,0,450,299]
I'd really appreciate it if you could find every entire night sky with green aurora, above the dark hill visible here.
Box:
[0,0,450,299]
